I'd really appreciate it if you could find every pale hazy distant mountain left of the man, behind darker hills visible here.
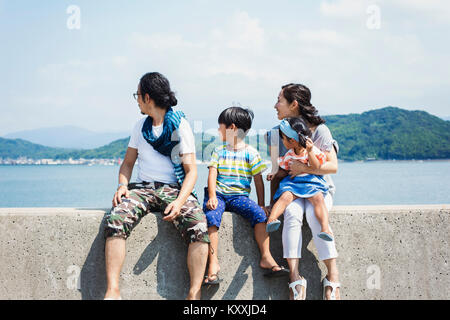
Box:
[4,126,129,149]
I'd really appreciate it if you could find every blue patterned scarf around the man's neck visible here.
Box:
[142,108,197,198]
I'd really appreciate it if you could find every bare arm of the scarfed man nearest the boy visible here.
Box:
[163,153,197,221]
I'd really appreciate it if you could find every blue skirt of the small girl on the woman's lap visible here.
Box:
[273,174,328,200]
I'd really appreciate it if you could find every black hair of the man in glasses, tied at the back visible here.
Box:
[139,72,178,110]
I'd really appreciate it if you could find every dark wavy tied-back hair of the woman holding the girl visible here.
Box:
[281,83,325,126]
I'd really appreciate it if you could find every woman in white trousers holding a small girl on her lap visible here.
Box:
[268,83,340,299]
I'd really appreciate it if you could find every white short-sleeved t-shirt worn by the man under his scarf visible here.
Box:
[128,117,195,184]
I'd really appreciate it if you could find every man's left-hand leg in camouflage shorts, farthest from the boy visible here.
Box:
[105,189,153,299]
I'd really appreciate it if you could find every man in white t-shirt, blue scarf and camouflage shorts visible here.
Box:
[105,72,209,299]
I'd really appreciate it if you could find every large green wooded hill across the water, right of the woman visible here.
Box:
[324,107,450,160]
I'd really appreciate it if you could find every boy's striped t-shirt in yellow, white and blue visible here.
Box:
[208,144,267,196]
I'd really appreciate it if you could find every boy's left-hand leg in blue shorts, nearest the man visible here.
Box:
[203,191,225,283]
